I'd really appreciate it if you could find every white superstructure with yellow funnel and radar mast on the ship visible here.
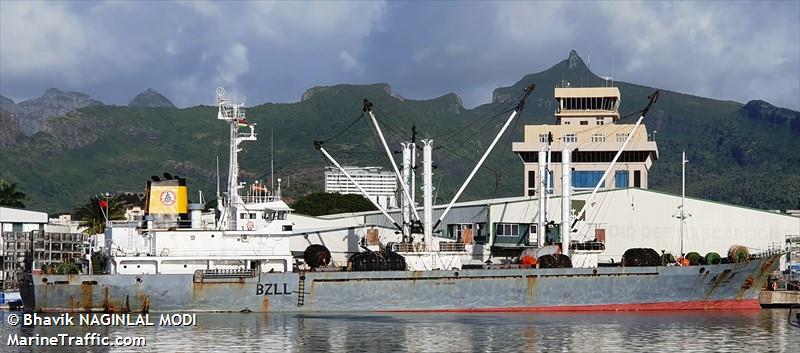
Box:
[104,88,302,274]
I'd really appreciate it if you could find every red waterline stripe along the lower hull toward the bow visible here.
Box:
[376,299,761,313]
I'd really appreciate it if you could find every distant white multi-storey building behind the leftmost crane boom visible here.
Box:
[325,167,397,208]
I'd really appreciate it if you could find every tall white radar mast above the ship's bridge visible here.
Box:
[217,87,256,229]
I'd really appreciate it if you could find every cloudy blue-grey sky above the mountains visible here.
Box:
[0,0,800,110]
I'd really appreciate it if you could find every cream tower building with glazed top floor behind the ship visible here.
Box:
[512,85,658,196]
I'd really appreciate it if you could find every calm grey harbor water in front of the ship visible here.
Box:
[0,309,800,352]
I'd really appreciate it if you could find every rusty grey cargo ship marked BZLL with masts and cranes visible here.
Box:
[17,85,782,312]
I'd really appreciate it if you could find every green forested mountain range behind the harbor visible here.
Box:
[0,52,800,212]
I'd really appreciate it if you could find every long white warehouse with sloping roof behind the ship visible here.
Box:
[314,188,800,263]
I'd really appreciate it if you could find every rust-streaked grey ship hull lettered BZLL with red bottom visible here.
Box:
[21,255,779,312]
